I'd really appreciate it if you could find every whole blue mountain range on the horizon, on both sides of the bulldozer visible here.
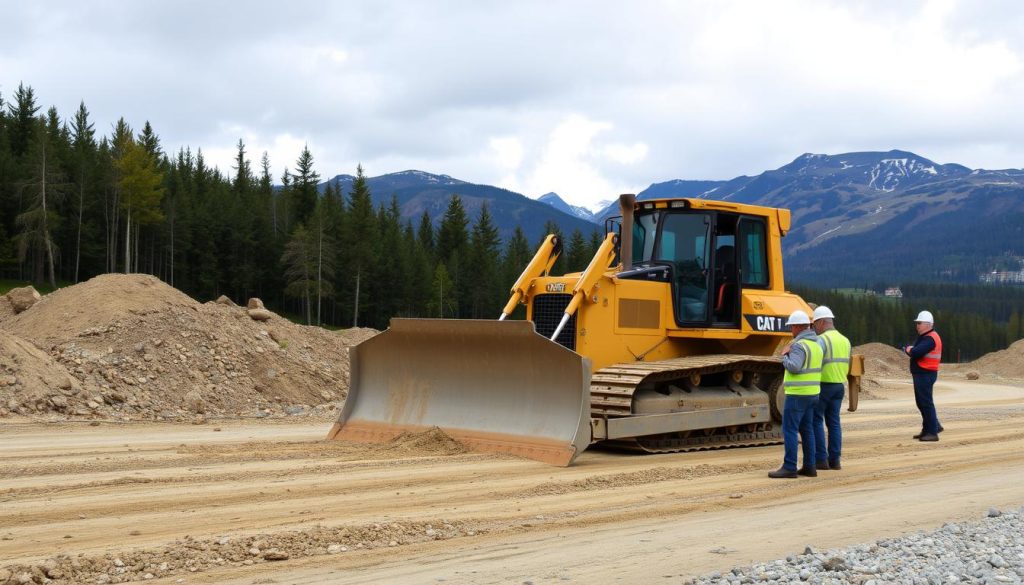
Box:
[311,151,1024,287]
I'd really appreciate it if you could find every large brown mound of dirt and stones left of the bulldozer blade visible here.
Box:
[0,275,376,419]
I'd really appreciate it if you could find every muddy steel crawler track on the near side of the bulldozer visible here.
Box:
[591,354,782,453]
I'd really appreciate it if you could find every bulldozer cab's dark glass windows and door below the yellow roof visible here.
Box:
[631,206,769,329]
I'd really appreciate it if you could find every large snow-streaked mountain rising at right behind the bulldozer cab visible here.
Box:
[585,151,1024,286]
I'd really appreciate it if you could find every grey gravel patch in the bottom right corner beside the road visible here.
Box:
[688,508,1024,585]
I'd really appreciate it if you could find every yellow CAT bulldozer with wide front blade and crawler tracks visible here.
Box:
[328,195,863,466]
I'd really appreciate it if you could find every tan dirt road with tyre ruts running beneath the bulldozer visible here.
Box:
[0,380,1024,584]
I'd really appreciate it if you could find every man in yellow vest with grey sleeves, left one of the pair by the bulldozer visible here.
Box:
[768,310,824,478]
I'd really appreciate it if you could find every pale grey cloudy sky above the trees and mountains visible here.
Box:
[0,0,1024,211]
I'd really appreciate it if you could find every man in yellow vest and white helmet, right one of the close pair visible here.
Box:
[812,305,850,469]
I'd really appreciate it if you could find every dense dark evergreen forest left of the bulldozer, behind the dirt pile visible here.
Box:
[0,84,599,328]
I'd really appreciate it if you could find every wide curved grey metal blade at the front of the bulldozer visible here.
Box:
[328,319,591,466]
